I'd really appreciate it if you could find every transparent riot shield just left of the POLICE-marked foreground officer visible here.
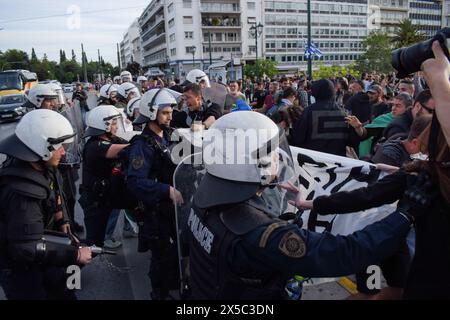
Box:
[173,153,206,297]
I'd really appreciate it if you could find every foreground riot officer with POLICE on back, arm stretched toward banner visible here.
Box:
[183,112,413,299]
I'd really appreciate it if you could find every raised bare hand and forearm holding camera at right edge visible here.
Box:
[422,41,450,146]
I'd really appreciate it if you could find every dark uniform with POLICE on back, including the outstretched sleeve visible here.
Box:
[188,173,411,299]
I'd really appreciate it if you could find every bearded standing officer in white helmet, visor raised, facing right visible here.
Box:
[127,89,183,299]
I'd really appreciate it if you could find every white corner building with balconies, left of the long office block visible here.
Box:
[139,0,262,77]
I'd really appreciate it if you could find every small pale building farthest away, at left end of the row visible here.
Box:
[120,19,142,69]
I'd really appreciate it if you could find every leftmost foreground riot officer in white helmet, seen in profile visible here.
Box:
[0,110,91,299]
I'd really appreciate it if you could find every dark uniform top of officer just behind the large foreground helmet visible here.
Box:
[170,102,223,128]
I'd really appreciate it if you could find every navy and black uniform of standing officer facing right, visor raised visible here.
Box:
[127,126,179,299]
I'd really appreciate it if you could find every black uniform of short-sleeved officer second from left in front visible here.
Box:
[79,136,121,247]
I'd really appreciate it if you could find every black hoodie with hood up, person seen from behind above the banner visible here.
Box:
[293,79,359,157]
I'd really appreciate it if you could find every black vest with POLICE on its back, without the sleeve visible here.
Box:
[188,203,286,300]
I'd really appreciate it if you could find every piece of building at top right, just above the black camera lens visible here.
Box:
[409,0,443,37]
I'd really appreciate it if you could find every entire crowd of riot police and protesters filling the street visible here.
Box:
[0,40,450,299]
